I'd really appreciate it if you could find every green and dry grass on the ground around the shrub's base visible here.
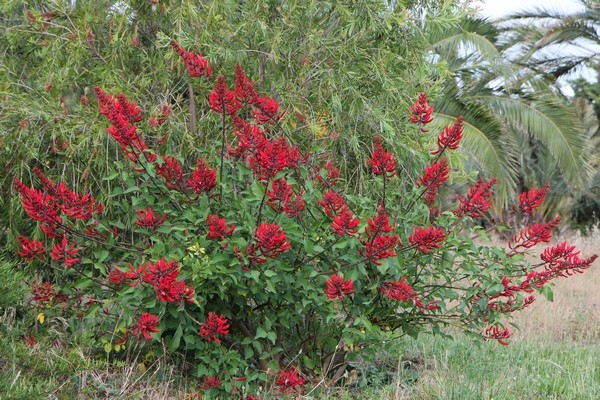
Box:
[0,231,600,400]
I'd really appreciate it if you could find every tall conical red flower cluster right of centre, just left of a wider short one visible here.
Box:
[359,205,401,265]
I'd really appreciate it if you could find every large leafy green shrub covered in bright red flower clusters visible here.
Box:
[14,42,596,399]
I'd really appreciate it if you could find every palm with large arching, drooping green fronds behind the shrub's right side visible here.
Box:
[430,19,591,211]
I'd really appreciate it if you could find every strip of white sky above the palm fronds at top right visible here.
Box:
[479,0,581,19]
